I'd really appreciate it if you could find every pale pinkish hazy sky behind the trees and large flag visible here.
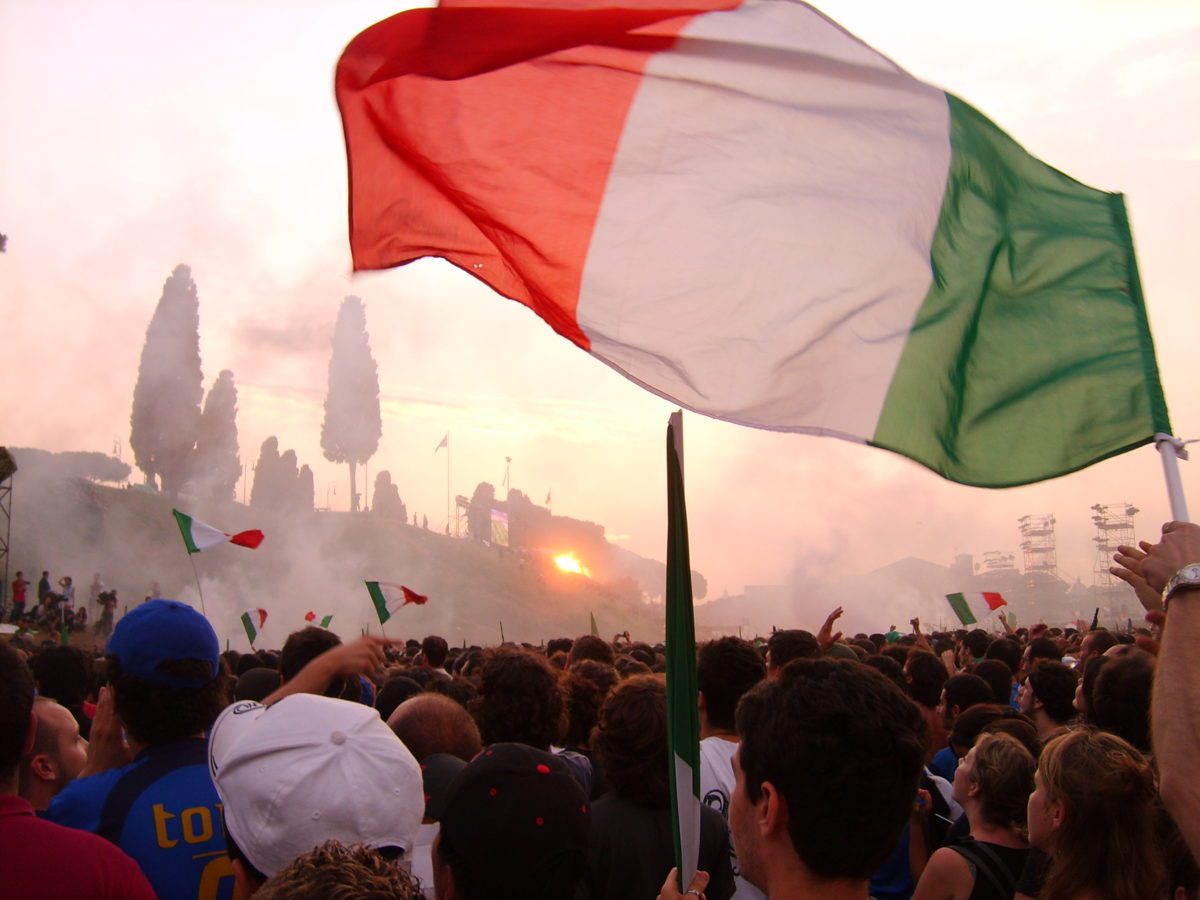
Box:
[0,0,1200,624]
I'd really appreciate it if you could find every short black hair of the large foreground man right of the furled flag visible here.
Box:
[737,659,926,878]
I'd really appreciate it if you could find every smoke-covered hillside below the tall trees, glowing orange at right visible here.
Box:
[11,473,662,649]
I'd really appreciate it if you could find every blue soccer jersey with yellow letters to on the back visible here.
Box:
[47,738,234,900]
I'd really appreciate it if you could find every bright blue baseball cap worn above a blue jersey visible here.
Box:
[108,598,221,688]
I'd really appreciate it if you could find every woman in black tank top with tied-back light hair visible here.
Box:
[912,734,1037,900]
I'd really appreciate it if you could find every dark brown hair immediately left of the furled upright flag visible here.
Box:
[592,676,671,809]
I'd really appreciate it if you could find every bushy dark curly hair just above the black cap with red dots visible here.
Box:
[470,647,566,750]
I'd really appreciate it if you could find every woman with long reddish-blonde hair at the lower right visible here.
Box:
[1028,728,1166,900]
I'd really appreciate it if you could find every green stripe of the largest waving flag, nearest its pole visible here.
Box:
[870,96,1171,487]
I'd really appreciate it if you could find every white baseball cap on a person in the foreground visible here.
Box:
[209,694,425,876]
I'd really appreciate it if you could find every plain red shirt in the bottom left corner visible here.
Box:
[0,794,155,900]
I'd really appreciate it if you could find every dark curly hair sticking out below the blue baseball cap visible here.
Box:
[108,656,232,746]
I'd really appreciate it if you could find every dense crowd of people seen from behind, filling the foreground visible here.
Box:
[0,523,1200,900]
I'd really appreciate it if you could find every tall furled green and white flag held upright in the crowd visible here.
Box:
[666,412,700,890]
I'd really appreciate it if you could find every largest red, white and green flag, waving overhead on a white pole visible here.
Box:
[336,0,1170,486]
